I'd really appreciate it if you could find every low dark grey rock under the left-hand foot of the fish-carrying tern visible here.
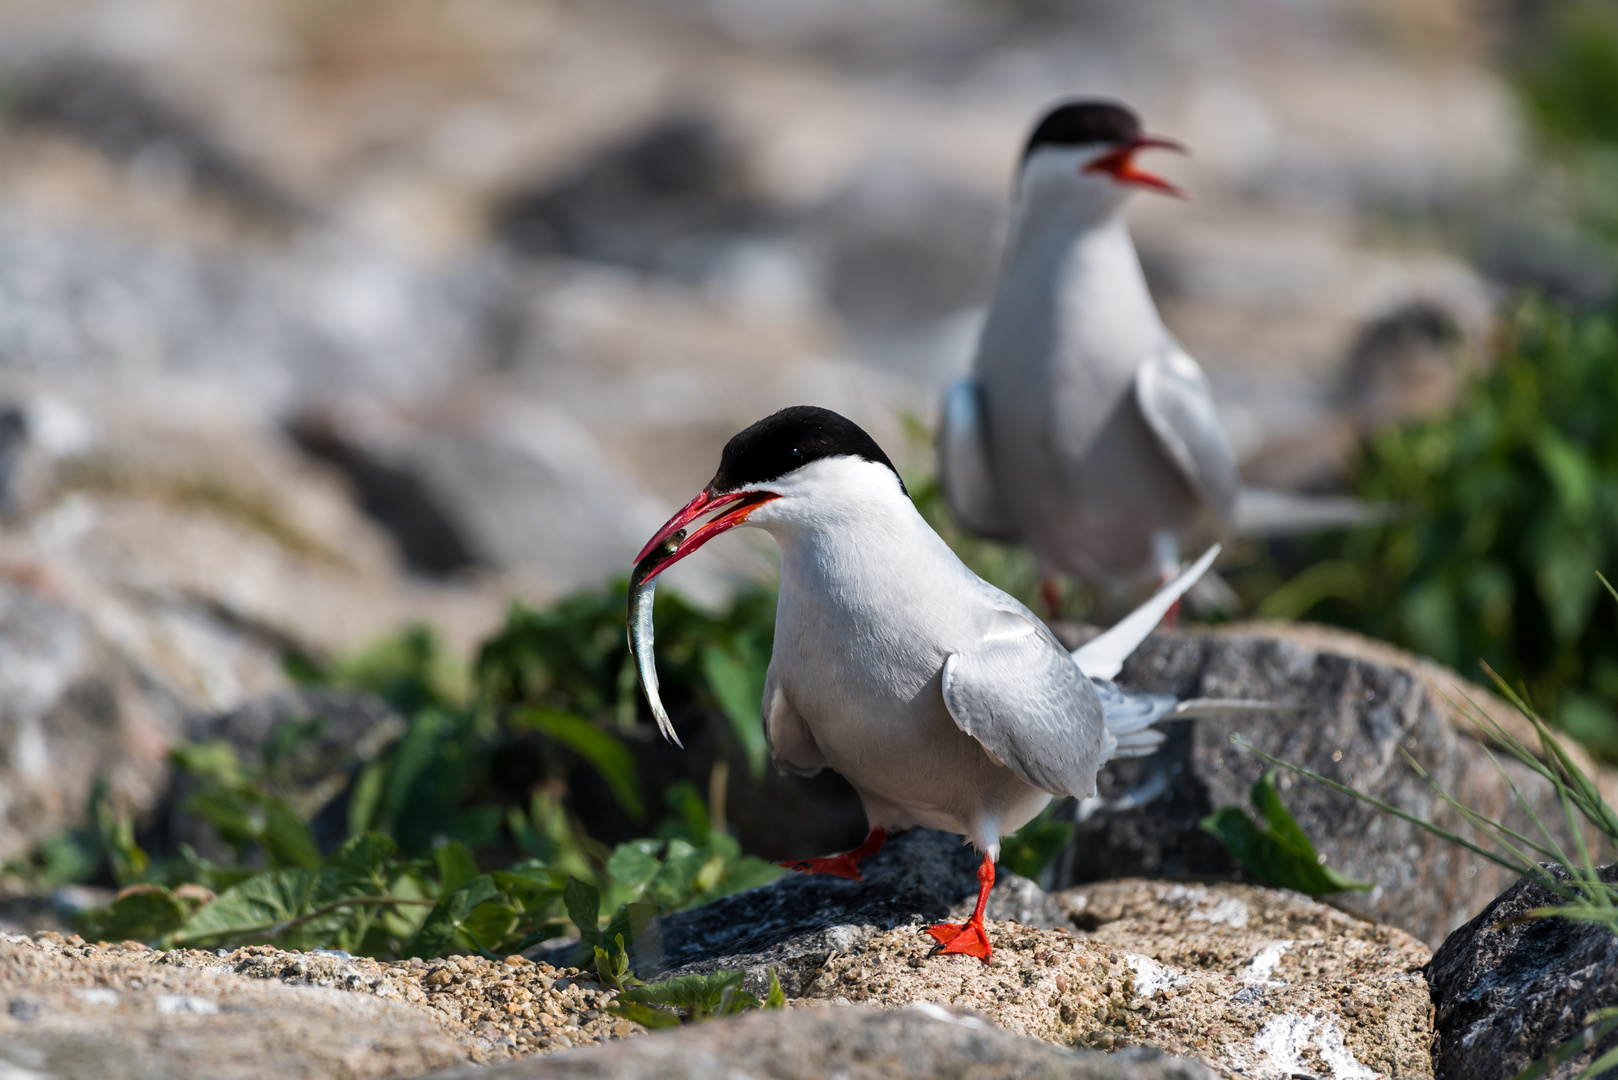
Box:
[636,829,1061,996]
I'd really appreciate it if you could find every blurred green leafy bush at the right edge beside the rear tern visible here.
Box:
[1233,298,1618,758]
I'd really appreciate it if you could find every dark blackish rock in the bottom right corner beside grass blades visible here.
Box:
[1427,866,1618,1080]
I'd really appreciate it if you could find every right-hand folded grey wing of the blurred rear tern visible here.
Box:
[1134,342,1241,521]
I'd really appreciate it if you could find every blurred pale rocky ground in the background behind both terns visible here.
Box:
[0,0,1618,952]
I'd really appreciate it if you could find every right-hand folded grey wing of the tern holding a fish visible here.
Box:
[943,612,1105,798]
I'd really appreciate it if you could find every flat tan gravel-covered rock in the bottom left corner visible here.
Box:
[0,933,627,1077]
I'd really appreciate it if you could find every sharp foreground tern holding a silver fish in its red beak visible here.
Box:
[629,406,1252,962]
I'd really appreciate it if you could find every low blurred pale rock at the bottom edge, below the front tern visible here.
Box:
[417,1006,1212,1080]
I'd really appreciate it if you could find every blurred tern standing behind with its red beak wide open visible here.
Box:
[938,100,1377,621]
